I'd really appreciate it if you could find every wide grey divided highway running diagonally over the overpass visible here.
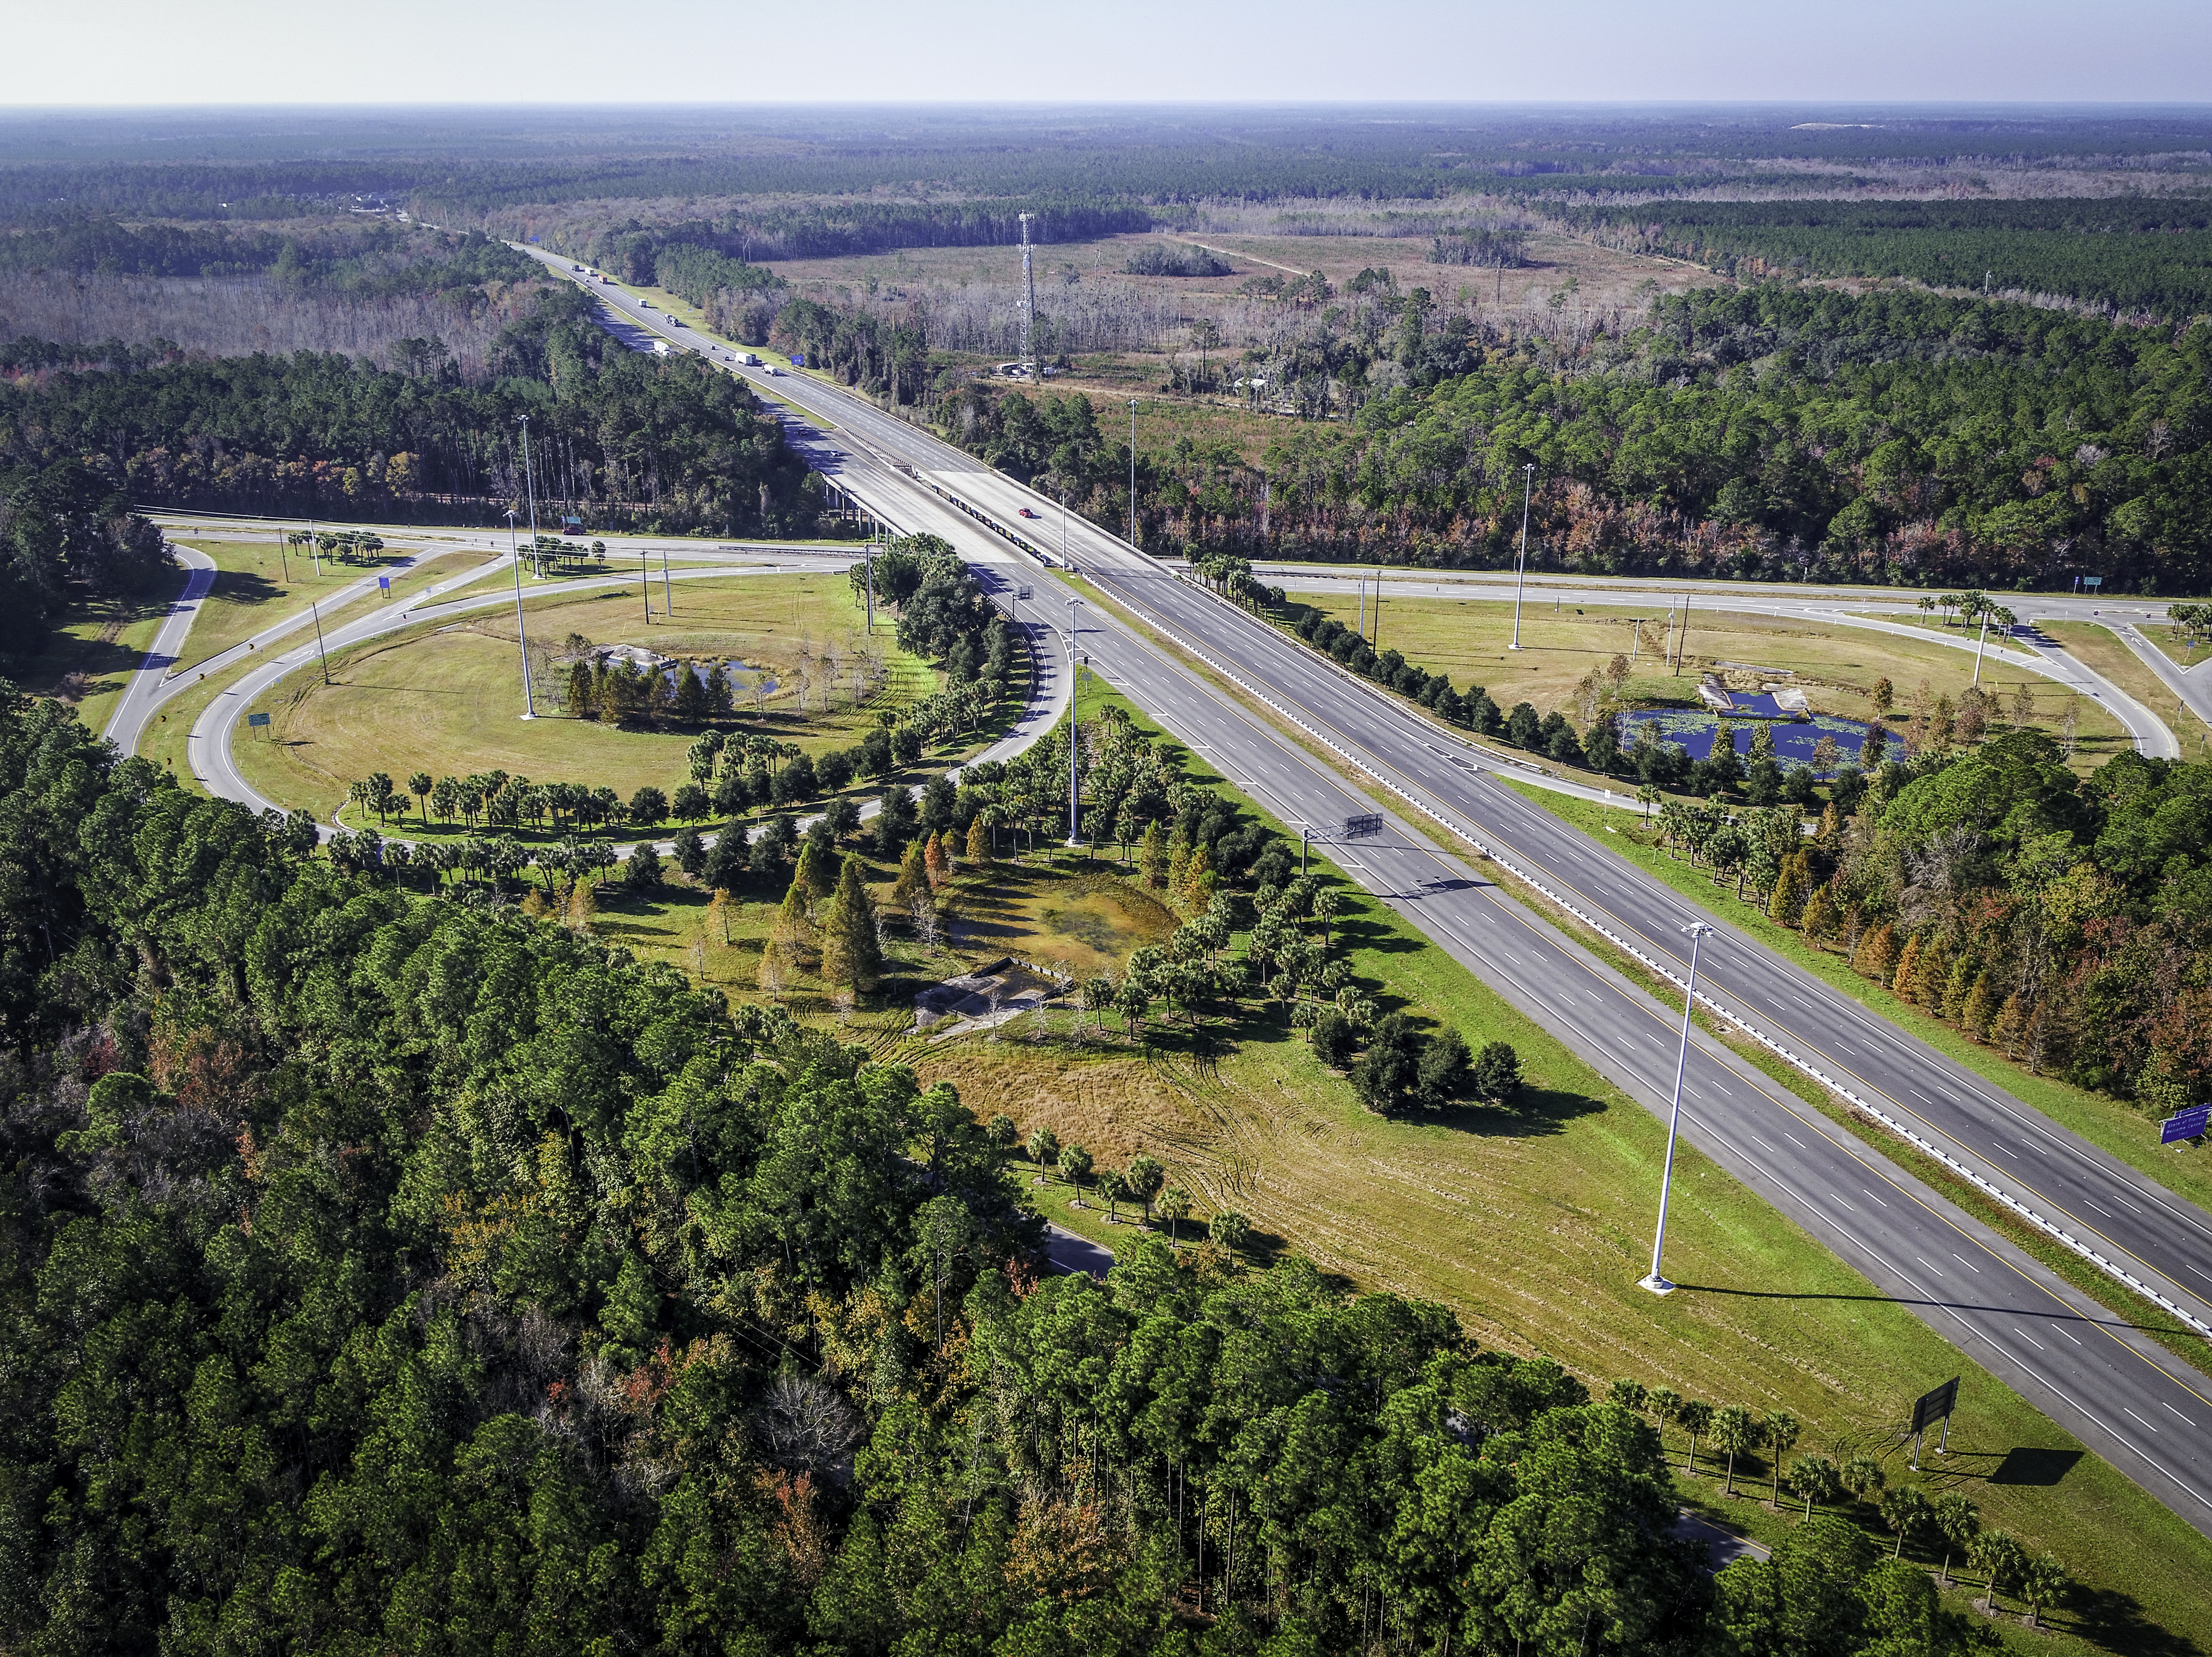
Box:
[513,259,2212,1533]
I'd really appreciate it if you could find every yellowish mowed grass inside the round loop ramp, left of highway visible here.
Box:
[235,575,935,810]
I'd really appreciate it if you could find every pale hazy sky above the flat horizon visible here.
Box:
[7,0,2212,106]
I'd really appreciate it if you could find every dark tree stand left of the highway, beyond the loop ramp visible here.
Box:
[0,285,821,533]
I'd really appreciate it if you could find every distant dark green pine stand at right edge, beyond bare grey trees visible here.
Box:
[1566,195,2212,321]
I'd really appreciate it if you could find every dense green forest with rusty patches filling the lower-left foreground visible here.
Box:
[0,681,2017,1657]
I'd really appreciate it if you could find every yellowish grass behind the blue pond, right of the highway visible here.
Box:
[1289,591,2132,763]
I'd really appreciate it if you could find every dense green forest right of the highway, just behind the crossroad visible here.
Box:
[1013,283,2212,593]
